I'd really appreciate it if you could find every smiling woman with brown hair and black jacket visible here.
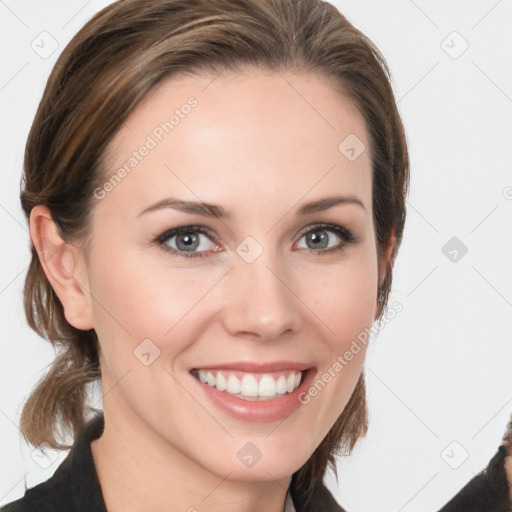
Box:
[0,0,409,512]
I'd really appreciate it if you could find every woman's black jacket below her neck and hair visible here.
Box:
[0,413,345,512]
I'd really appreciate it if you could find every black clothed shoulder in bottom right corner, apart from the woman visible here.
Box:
[439,446,510,512]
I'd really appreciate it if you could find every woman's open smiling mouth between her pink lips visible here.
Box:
[190,368,308,401]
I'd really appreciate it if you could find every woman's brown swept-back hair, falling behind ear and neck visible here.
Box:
[20,0,409,499]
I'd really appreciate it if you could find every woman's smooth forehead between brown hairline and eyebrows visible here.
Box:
[98,66,371,216]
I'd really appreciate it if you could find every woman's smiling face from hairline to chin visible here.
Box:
[81,70,378,480]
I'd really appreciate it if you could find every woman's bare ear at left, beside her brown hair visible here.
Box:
[30,205,94,330]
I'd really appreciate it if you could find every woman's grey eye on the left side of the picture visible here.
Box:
[155,226,219,258]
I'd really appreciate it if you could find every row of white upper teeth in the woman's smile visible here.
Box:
[194,370,302,398]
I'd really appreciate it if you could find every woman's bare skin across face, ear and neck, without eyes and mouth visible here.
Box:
[30,69,394,512]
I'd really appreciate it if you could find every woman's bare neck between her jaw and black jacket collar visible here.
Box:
[91,401,290,512]
